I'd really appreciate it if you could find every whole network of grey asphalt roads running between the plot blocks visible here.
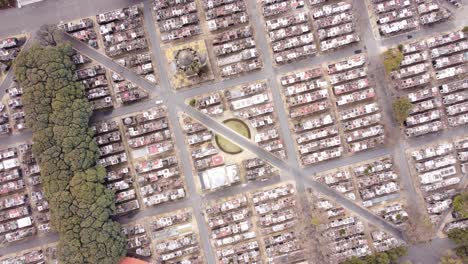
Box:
[0,0,468,263]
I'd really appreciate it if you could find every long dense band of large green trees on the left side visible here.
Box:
[14,44,126,264]
